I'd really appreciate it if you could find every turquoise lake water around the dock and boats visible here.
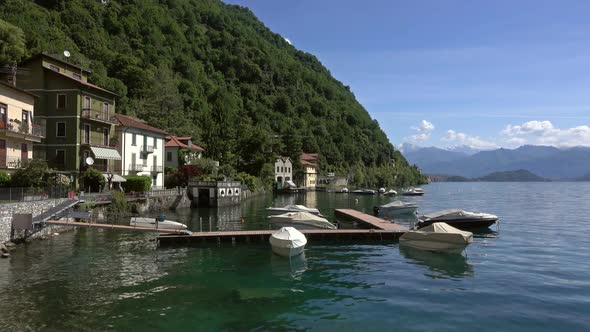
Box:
[0,183,590,331]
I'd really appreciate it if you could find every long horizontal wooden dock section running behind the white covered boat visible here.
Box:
[158,229,404,246]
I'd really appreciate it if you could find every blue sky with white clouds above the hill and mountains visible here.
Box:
[225,0,590,149]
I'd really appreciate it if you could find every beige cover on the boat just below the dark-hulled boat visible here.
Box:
[400,222,473,244]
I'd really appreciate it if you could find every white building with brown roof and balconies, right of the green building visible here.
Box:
[115,114,168,188]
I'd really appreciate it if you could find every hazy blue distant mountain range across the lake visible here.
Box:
[404,145,590,180]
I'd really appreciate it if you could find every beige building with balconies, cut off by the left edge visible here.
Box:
[0,83,45,173]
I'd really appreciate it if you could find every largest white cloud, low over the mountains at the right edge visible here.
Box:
[500,120,590,147]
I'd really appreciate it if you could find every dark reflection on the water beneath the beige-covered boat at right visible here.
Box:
[399,245,474,278]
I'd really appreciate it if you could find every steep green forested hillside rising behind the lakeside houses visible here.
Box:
[0,0,420,185]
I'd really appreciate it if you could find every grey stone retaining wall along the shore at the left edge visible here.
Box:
[0,198,67,243]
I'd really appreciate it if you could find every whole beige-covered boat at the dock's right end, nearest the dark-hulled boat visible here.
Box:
[399,222,473,253]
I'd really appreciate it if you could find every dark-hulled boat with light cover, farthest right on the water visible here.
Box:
[417,209,498,229]
